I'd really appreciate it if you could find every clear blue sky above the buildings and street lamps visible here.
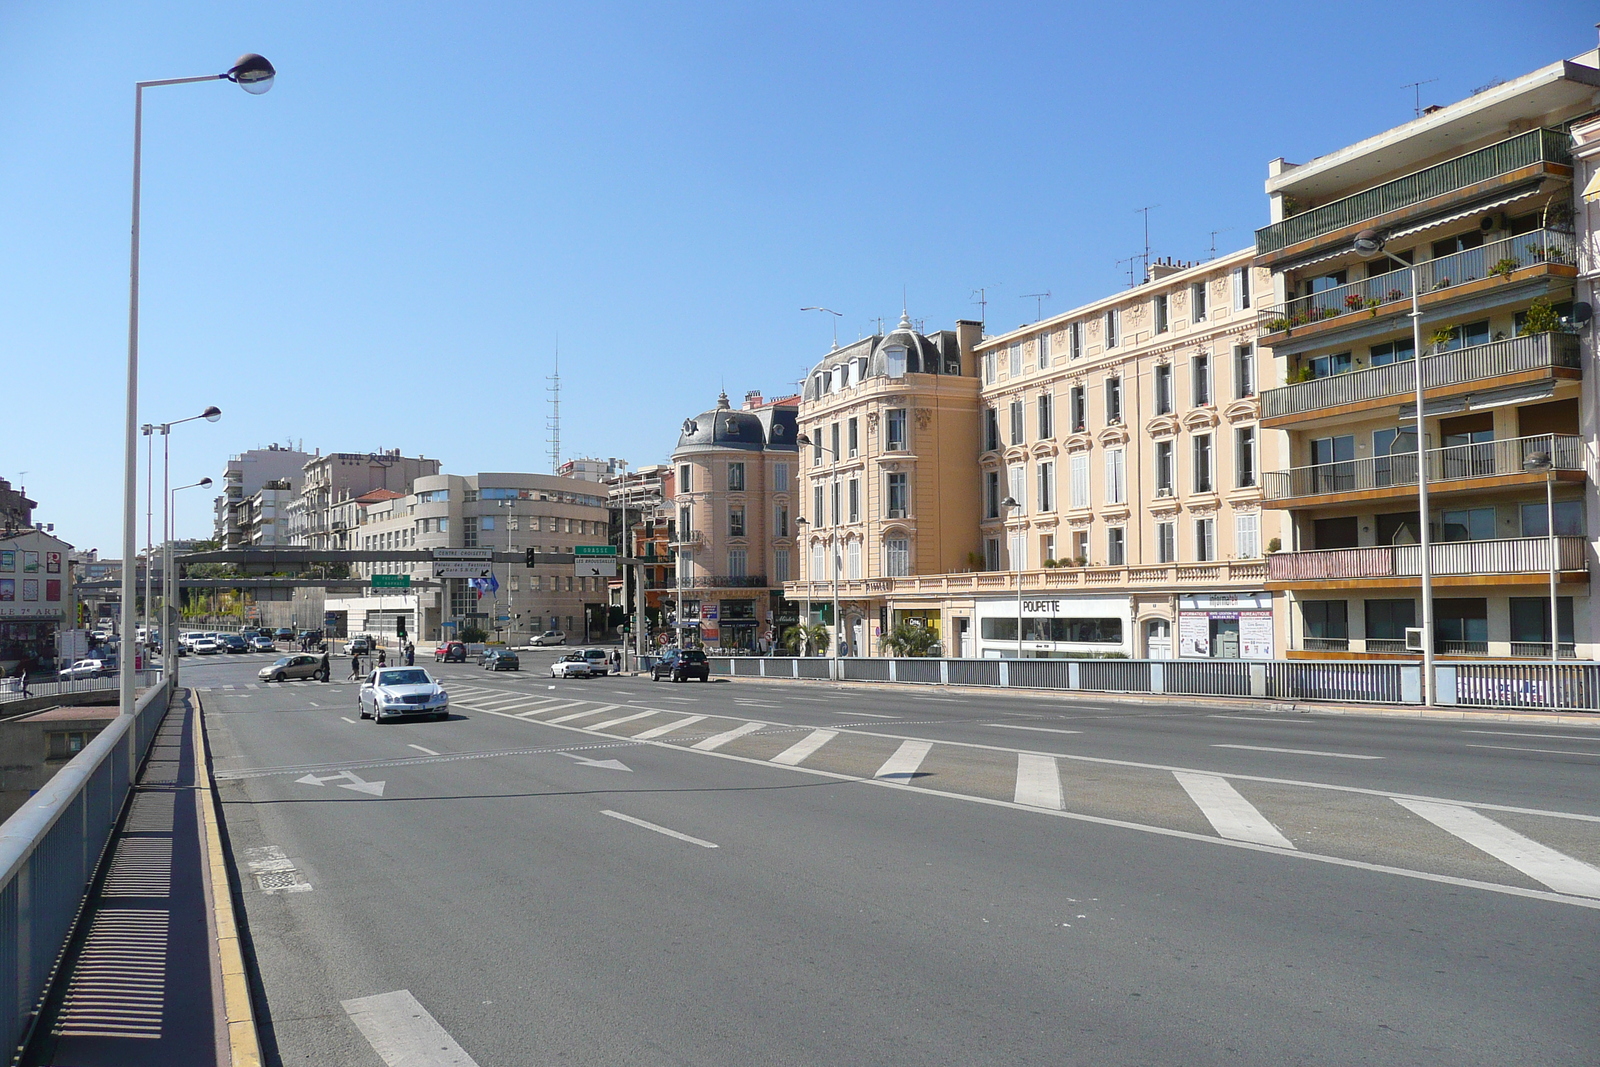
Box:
[0,0,1595,555]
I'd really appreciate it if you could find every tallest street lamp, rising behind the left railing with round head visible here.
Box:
[117,53,277,715]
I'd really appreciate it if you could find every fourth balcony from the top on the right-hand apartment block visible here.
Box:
[1262,434,1584,507]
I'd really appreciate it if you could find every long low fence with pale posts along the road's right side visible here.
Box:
[709,656,1600,712]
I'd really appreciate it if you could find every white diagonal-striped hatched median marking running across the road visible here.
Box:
[451,686,1600,907]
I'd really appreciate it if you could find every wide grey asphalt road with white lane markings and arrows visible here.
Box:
[184,654,1600,1067]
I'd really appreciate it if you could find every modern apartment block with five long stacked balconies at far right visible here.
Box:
[1254,53,1600,657]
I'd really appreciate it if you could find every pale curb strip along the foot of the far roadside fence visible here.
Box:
[712,675,1600,729]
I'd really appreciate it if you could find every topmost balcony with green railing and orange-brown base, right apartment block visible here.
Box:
[1256,128,1573,261]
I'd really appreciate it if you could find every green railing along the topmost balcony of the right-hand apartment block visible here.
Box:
[1256,130,1573,256]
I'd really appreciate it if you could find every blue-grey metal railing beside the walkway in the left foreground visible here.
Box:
[0,683,168,1049]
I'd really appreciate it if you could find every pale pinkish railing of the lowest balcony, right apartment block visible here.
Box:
[1267,537,1587,582]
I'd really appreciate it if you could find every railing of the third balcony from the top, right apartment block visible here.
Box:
[1261,333,1579,419]
